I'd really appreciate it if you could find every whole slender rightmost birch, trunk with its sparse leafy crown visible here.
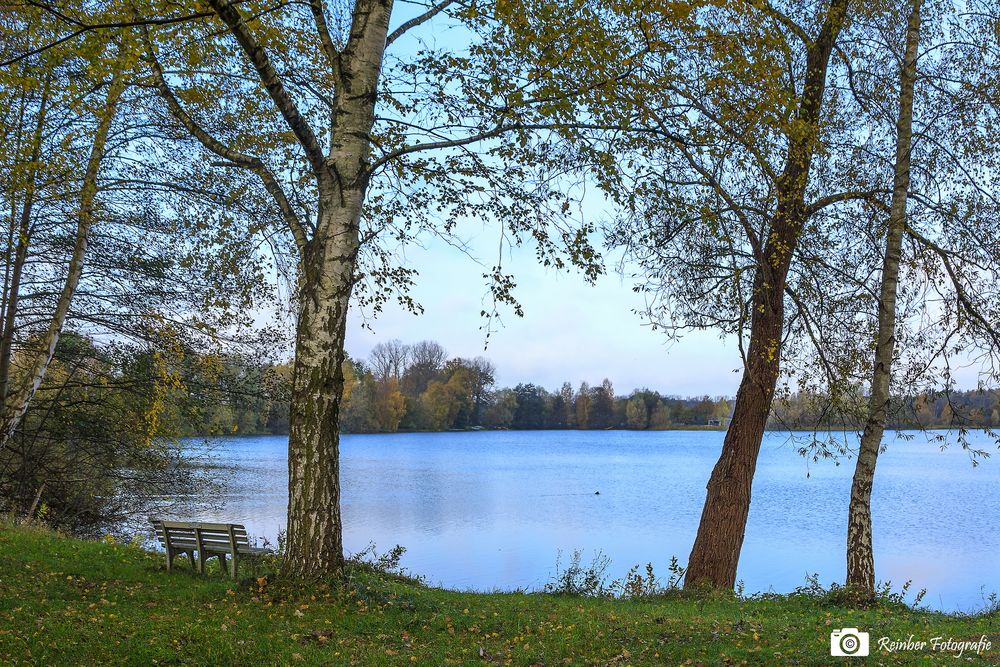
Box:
[812,0,1000,599]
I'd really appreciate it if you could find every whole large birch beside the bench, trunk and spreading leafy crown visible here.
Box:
[125,0,649,576]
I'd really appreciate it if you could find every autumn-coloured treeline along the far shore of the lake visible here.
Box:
[180,340,1000,435]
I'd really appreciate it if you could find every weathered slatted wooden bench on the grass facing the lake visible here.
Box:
[149,518,271,579]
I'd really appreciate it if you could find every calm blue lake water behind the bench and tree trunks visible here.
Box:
[176,431,1000,611]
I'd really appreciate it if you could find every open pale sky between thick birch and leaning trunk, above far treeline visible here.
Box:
[347,233,741,396]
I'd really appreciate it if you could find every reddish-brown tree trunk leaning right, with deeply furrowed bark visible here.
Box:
[684,0,849,588]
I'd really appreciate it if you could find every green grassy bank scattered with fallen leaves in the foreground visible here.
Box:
[0,524,1000,665]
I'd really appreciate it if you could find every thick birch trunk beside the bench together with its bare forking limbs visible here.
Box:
[154,0,393,578]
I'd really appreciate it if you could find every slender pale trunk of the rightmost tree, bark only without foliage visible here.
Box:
[847,0,921,599]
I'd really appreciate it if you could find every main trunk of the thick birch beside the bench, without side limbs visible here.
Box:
[283,0,392,577]
